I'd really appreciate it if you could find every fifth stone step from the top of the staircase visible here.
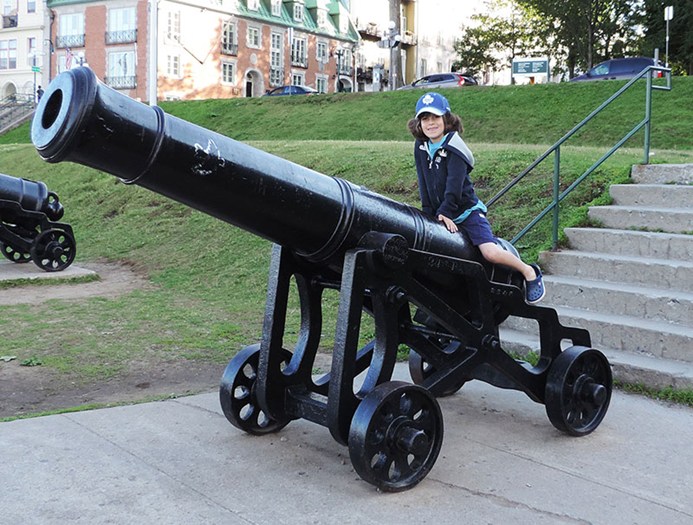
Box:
[539,250,693,293]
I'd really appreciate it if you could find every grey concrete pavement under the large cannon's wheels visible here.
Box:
[0,365,693,525]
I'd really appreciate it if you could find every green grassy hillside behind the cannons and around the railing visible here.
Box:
[0,74,693,414]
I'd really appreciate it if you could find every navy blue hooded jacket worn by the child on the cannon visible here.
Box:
[414,132,479,220]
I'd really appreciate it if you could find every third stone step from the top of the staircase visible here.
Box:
[588,206,693,233]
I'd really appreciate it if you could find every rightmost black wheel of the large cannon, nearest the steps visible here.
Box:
[545,346,613,436]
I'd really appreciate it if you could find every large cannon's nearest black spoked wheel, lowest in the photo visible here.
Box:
[349,381,443,492]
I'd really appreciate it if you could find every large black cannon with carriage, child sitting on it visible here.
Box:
[31,68,612,491]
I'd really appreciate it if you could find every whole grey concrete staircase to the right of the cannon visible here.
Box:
[500,164,693,389]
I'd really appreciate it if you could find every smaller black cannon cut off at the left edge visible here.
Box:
[0,173,76,272]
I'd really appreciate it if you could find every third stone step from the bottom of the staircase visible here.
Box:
[544,275,693,326]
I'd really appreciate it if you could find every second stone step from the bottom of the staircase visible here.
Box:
[503,306,693,364]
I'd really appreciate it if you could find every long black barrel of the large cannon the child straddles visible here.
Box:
[31,68,481,263]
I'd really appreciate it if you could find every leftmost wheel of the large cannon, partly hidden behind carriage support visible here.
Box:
[219,344,291,436]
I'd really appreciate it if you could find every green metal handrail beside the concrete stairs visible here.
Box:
[486,66,671,250]
